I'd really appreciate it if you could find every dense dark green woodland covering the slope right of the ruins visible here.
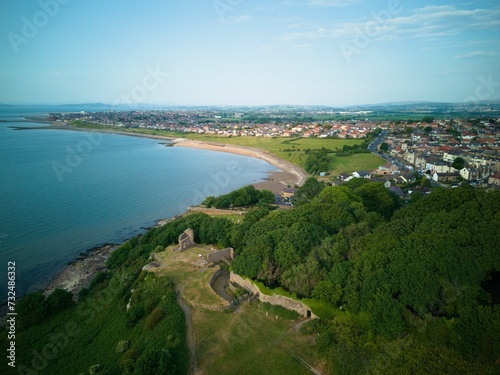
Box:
[7,179,500,374]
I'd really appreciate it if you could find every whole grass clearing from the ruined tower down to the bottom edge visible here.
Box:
[155,246,320,375]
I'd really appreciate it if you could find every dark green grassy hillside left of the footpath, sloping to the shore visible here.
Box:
[2,242,188,375]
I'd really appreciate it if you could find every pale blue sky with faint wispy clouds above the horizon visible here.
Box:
[0,0,500,106]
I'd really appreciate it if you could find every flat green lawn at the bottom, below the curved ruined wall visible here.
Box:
[193,303,320,375]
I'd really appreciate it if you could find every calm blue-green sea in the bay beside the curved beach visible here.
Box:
[0,107,276,303]
